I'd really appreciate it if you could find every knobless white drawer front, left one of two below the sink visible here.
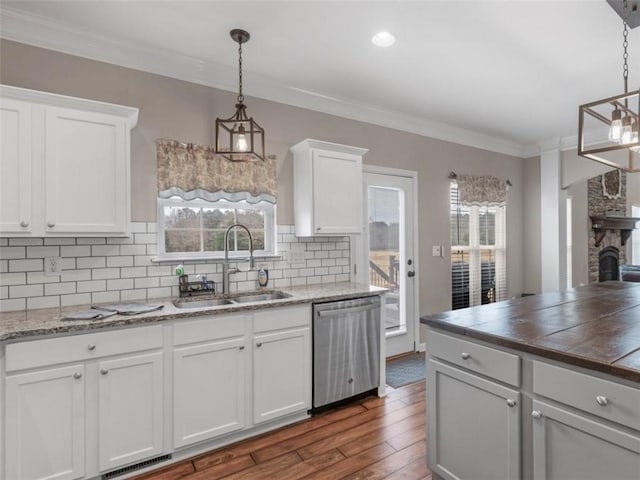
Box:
[173,314,247,345]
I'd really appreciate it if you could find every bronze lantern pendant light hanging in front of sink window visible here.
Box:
[216,28,265,162]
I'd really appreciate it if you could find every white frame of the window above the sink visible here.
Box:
[156,196,278,261]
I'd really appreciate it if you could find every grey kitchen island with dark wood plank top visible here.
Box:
[421,282,640,480]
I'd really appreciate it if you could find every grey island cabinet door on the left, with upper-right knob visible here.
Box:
[427,359,521,480]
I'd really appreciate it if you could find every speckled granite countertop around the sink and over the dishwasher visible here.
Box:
[0,282,386,341]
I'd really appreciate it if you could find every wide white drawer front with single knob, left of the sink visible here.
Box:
[6,325,163,372]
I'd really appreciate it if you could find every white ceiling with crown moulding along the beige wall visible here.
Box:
[0,0,640,157]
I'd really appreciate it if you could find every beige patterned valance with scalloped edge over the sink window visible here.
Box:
[156,140,277,204]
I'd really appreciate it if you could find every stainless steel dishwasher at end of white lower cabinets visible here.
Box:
[312,296,380,411]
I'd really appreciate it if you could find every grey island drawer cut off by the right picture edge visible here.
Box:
[533,361,640,430]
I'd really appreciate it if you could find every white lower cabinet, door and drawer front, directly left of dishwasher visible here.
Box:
[253,305,311,424]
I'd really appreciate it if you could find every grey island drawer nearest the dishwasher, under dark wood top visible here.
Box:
[427,330,520,387]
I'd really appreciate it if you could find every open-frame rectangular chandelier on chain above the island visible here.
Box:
[578,0,640,172]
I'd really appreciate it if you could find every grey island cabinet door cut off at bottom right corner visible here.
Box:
[533,400,640,480]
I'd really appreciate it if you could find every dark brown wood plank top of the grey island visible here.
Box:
[420,282,640,382]
